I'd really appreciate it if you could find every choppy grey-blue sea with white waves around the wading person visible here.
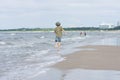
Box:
[0,31,120,80]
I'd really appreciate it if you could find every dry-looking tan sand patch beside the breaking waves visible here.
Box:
[53,45,120,71]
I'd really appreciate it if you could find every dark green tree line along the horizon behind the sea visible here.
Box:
[0,26,120,31]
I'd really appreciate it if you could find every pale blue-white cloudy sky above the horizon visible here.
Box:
[0,0,120,29]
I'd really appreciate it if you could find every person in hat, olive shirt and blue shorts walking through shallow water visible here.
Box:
[54,22,64,49]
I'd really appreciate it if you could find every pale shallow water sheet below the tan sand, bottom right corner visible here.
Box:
[64,69,120,80]
